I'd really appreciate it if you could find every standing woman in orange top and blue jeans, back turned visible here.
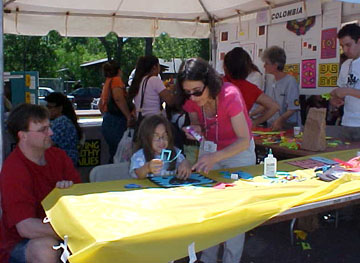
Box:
[99,61,135,163]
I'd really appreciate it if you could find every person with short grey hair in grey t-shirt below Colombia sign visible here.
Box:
[256,46,301,130]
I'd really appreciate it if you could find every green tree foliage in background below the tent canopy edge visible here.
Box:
[4,31,209,87]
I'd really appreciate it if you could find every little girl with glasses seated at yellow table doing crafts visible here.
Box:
[130,115,191,180]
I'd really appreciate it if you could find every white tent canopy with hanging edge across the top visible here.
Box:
[4,0,314,38]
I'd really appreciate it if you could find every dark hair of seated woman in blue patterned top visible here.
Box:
[45,92,82,140]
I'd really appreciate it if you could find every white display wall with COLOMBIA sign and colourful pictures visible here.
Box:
[216,0,360,95]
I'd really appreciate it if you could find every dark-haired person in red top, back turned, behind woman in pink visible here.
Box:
[223,47,279,126]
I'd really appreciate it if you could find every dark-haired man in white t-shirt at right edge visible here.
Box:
[330,24,360,141]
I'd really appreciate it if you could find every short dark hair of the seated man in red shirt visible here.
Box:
[7,103,50,142]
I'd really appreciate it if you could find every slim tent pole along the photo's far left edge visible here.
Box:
[0,1,5,170]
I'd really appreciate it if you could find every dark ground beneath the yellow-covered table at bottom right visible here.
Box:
[241,208,360,263]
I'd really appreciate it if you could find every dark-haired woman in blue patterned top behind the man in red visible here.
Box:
[45,92,83,166]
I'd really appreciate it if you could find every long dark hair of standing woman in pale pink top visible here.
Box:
[129,56,159,100]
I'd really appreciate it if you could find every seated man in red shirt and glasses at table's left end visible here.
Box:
[0,104,80,263]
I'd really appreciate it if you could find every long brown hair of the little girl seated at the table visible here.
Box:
[135,115,176,170]
